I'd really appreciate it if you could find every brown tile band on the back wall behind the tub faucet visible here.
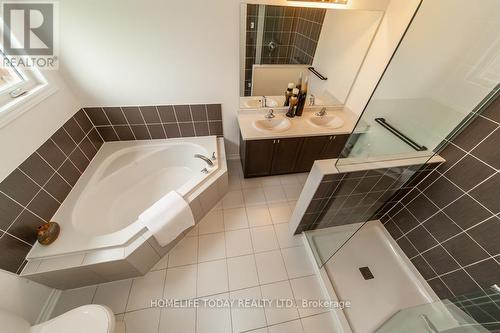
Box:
[85,104,223,141]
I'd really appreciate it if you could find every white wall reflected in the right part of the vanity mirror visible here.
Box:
[310,10,383,104]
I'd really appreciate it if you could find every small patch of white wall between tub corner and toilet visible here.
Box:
[0,270,54,324]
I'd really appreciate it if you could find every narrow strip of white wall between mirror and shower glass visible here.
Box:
[346,0,420,114]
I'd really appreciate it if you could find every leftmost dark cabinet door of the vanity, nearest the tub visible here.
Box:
[243,140,275,177]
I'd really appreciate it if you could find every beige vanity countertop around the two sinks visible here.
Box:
[238,108,358,140]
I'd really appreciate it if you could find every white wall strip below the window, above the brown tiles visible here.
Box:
[0,71,81,181]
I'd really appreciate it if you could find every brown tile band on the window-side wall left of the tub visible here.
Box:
[0,110,103,273]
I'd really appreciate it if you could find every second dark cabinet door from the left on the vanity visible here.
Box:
[271,138,303,175]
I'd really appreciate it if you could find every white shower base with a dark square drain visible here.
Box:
[300,221,439,333]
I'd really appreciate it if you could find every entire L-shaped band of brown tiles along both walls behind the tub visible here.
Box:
[0,104,223,273]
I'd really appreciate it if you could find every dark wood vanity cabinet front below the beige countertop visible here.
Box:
[240,134,349,178]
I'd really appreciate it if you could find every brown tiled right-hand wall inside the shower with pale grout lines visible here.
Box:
[382,98,500,299]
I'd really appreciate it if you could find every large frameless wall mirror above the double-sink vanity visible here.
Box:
[240,4,382,108]
